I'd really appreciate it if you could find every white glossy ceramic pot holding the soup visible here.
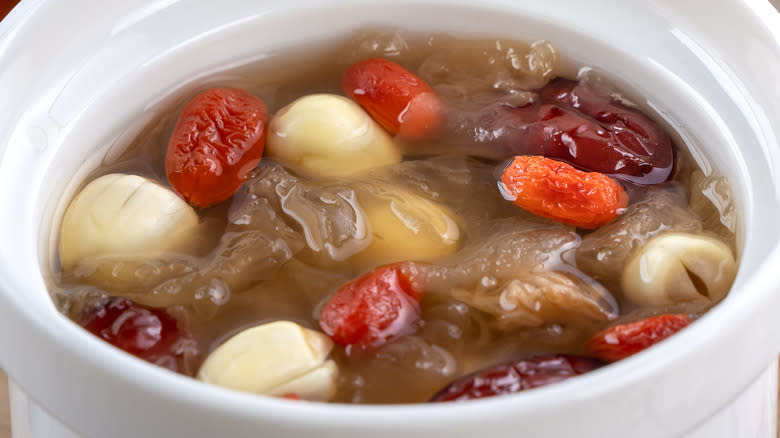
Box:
[0,0,780,438]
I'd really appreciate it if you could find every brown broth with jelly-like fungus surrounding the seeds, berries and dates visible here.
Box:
[52,30,736,403]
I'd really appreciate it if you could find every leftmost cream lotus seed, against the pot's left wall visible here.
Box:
[59,174,198,271]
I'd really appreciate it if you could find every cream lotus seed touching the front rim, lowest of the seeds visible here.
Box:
[198,321,338,401]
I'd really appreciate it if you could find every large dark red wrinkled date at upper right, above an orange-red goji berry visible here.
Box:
[466,79,674,184]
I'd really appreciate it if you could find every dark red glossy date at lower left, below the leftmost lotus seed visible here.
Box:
[80,298,195,372]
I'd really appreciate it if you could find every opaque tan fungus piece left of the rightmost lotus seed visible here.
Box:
[452,271,617,329]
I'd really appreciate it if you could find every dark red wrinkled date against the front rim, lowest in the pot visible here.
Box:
[430,354,604,402]
